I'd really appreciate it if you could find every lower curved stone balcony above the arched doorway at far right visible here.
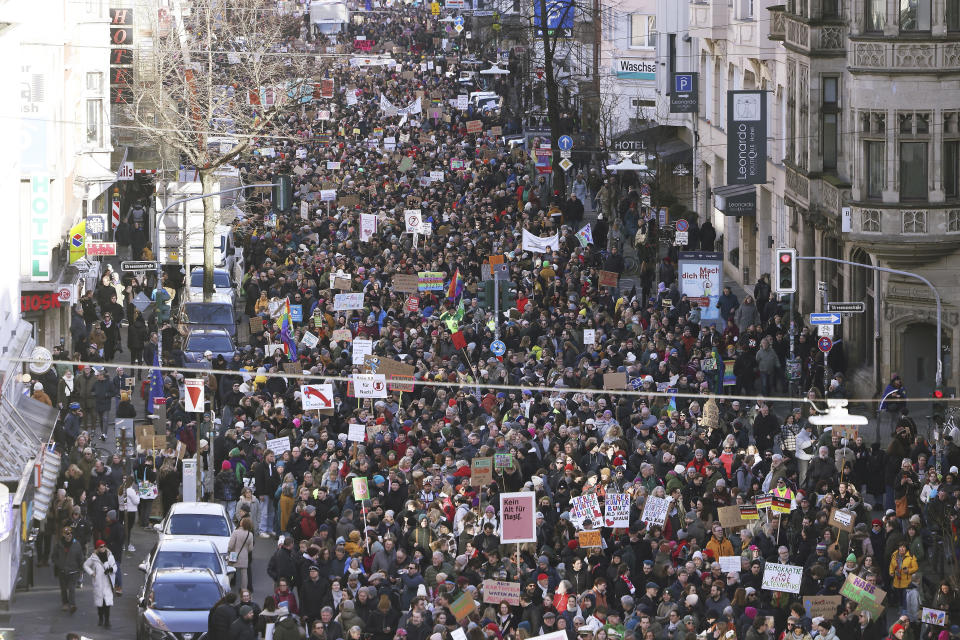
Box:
[847,202,960,266]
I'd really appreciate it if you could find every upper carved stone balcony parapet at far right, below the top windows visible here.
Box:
[847,38,960,74]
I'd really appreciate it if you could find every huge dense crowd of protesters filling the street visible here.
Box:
[38,1,960,640]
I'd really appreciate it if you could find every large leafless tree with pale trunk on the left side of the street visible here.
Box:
[128,0,312,295]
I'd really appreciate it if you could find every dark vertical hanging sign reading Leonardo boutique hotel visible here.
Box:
[727,91,767,185]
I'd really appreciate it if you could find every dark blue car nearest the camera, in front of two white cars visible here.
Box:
[137,568,226,640]
